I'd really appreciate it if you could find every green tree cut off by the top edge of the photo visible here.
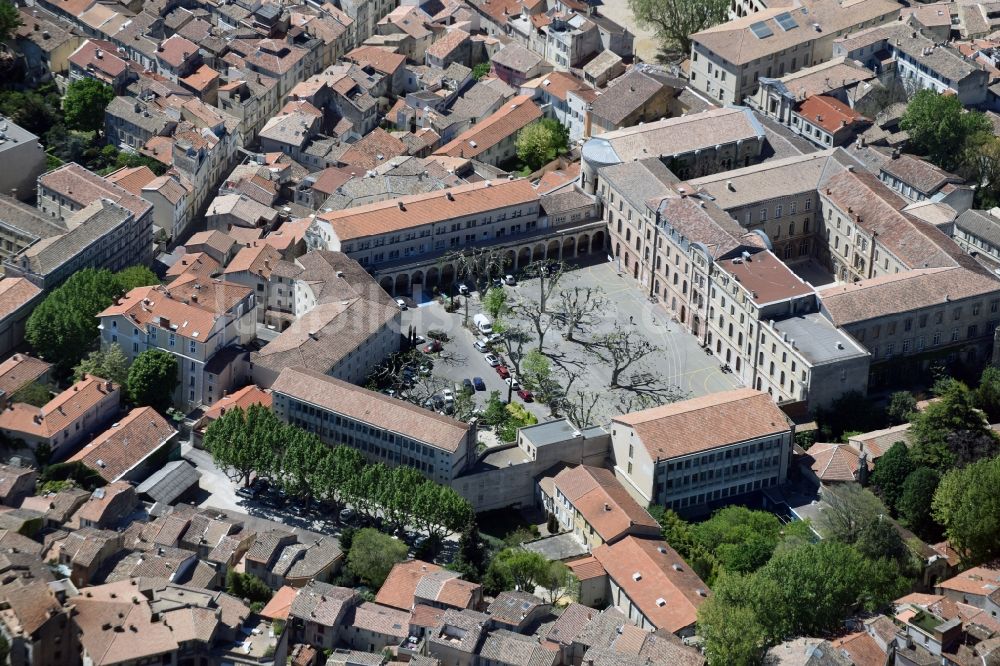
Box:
[628,0,729,57]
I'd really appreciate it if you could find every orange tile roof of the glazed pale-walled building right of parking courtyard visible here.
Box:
[613,388,790,459]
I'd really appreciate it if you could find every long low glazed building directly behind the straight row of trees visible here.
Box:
[271,367,476,484]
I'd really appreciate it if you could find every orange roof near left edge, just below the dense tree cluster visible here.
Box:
[0,376,119,439]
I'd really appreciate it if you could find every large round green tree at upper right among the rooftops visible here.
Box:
[899,88,993,170]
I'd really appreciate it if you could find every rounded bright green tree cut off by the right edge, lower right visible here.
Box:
[931,458,1000,565]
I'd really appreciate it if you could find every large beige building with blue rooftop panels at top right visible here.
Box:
[689,0,900,104]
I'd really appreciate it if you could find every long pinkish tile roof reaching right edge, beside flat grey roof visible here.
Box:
[819,267,1000,326]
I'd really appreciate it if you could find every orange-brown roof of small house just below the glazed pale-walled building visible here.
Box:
[555,465,660,541]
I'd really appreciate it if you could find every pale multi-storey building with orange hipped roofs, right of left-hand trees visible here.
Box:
[98,276,257,410]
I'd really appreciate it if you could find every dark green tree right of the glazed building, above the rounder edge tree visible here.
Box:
[910,379,997,472]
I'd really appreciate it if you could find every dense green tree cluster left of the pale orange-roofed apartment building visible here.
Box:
[24,266,159,376]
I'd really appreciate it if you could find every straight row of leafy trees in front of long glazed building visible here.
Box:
[204,405,473,539]
